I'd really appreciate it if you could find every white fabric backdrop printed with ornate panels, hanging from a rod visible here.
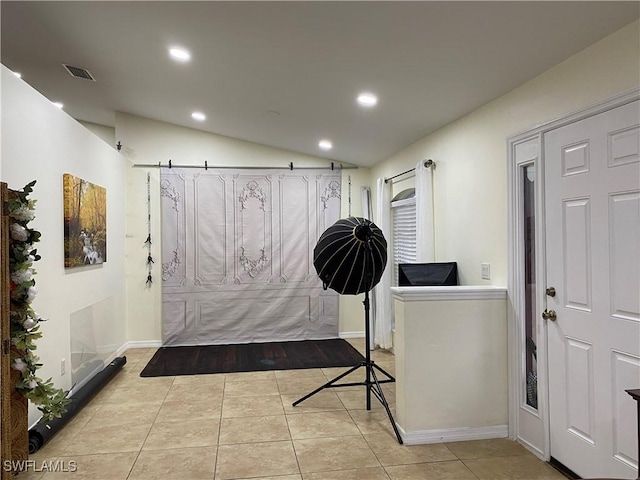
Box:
[160,168,341,346]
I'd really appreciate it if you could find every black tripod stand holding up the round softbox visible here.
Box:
[293,230,402,445]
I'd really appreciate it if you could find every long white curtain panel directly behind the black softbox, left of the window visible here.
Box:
[374,178,393,348]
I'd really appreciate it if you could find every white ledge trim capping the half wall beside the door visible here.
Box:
[391,285,507,302]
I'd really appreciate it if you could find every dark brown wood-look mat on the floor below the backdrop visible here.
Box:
[140,338,364,377]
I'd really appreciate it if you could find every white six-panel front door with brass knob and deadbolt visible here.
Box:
[544,101,640,478]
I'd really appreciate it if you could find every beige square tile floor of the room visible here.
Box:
[18,339,564,480]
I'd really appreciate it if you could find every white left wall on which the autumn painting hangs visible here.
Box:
[0,66,127,423]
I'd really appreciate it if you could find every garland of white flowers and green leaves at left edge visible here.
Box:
[8,180,70,421]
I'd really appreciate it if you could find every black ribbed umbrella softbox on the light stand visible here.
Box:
[313,217,387,295]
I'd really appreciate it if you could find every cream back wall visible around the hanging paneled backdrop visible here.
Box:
[116,113,369,342]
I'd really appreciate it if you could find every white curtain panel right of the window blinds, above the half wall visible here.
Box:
[416,160,435,263]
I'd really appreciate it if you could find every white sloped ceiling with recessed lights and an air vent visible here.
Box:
[0,1,640,166]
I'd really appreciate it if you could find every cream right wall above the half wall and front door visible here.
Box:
[371,21,640,286]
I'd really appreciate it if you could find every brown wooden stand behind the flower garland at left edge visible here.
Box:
[0,182,29,480]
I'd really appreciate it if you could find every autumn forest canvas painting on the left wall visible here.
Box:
[63,173,107,268]
